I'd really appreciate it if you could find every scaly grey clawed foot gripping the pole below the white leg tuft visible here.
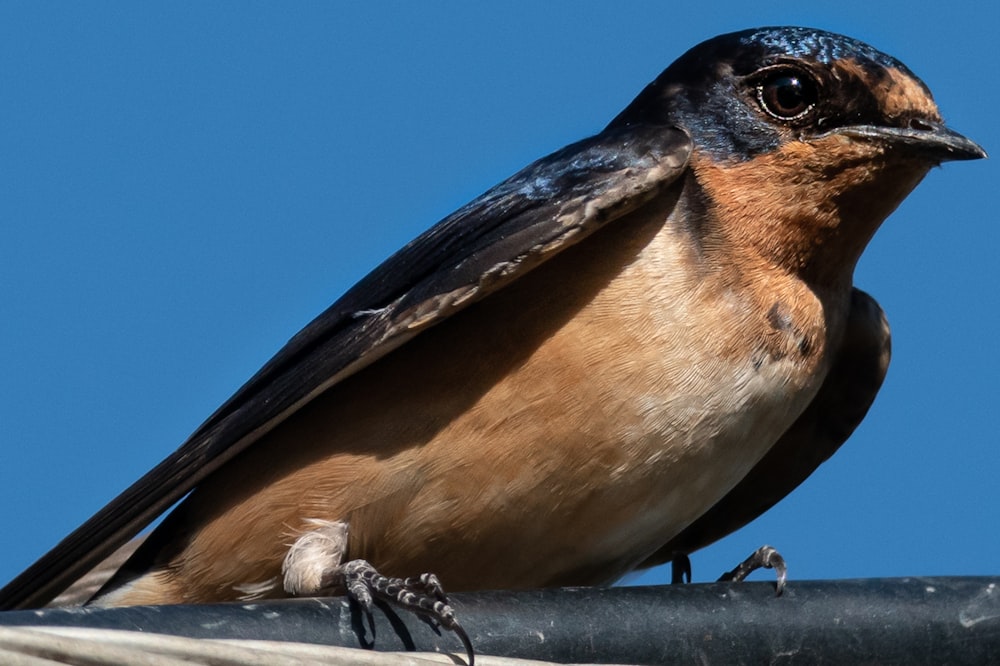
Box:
[340,560,475,666]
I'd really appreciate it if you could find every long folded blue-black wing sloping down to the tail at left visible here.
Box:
[0,120,691,610]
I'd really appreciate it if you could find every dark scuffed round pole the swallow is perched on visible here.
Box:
[0,577,1000,664]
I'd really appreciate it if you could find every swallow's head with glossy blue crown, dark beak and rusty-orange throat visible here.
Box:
[609,27,986,279]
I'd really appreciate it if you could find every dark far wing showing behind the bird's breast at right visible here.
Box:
[641,289,890,568]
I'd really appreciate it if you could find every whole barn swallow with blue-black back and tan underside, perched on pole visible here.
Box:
[0,27,986,656]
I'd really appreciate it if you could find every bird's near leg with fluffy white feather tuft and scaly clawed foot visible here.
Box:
[281,520,475,666]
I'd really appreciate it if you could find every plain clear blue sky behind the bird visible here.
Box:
[0,1,1000,582]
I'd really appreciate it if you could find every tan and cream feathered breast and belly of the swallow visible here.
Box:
[145,198,840,590]
